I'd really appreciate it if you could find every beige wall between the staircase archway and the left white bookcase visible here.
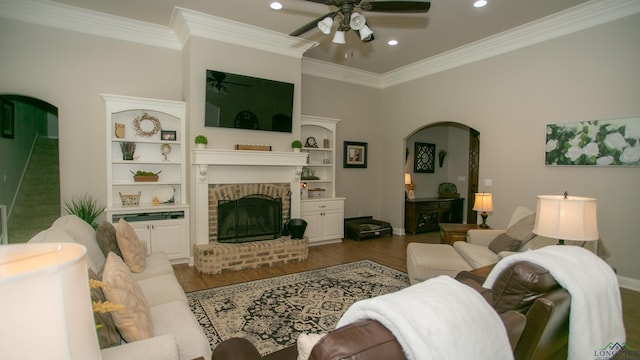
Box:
[0,18,182,211]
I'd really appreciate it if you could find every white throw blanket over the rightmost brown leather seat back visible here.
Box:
[483,245,625,360]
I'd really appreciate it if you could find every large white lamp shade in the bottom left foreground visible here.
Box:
[0,243,101,360]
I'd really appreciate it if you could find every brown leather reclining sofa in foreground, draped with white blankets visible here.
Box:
[212,262,571,360]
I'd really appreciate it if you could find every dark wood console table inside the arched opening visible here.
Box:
[404,198,464,234]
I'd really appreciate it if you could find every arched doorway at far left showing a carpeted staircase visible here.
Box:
[0,94,61,243]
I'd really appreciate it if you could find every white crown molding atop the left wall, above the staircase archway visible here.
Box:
[0,0,181,50]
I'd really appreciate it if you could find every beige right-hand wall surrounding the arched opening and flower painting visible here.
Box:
[380,15,640,279]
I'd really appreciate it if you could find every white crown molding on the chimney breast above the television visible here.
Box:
[169,7,318,59]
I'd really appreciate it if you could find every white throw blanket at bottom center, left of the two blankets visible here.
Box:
[337,276,513,360]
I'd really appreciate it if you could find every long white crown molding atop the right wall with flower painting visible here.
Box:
[381,0,640,88]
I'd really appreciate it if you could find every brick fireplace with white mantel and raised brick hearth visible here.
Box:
[191,149,308,274]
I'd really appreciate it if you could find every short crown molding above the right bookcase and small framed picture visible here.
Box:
[302,58,382,89]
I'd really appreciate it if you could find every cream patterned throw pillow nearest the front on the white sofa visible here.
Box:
[102,253,153,342]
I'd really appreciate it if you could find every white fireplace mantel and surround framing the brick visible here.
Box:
[191,149,308,244]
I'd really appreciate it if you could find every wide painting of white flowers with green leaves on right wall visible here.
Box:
[545,117,640,166]
